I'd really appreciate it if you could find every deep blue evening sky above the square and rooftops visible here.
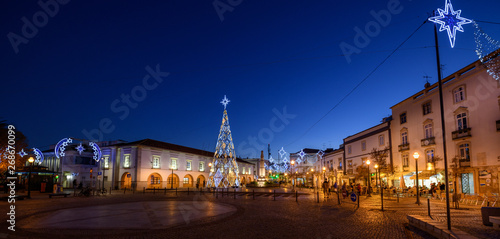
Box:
[0,0,500,157]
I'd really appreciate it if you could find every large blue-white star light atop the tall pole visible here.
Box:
[429,0,472,48]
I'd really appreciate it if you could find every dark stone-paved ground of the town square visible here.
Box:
[0,191,499,239]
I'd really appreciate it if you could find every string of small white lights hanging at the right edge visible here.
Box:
[474,22,500,80]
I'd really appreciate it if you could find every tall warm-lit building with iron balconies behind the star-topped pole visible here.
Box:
[391,57,500,193]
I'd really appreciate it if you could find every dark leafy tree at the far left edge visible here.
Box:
[0,120,28,183]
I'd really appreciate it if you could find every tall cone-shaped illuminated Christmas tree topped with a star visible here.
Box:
[208,96,240,188]
